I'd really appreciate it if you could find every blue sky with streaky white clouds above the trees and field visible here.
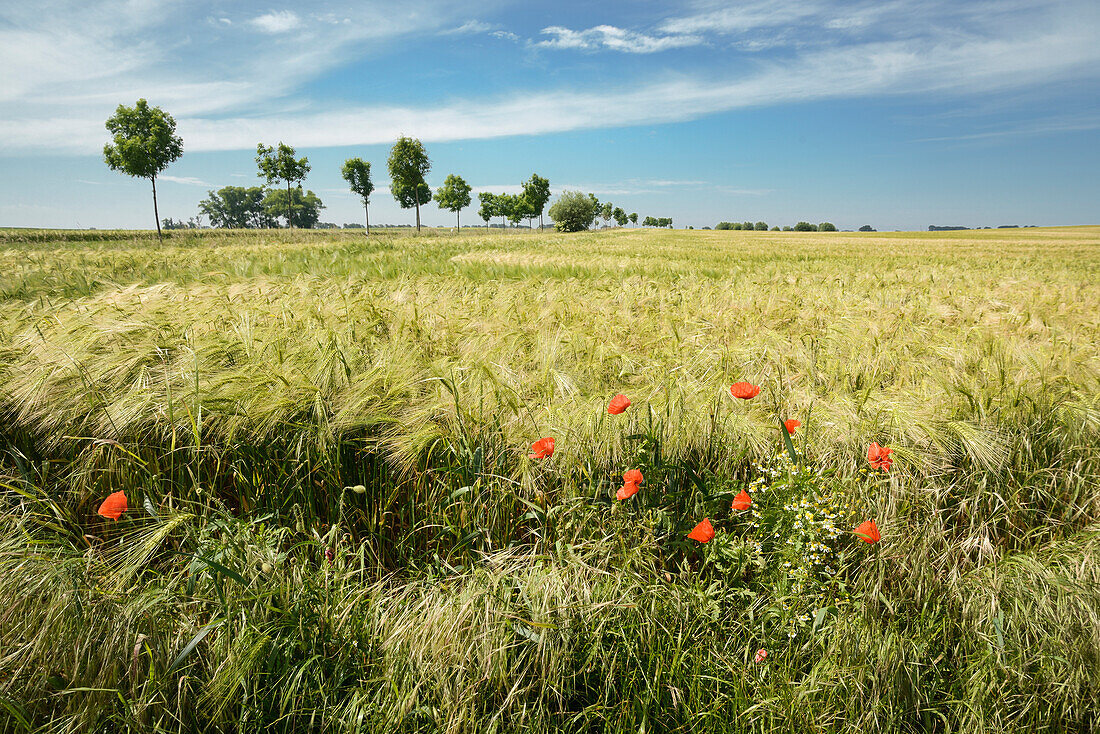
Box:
[0,0,1100,229]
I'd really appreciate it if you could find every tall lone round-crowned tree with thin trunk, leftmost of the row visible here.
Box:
[103,99,184,240]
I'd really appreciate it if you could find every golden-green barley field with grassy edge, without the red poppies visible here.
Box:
[0,227,1100,734]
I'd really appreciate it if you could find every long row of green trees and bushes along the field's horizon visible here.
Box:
[103,99,672,238]
